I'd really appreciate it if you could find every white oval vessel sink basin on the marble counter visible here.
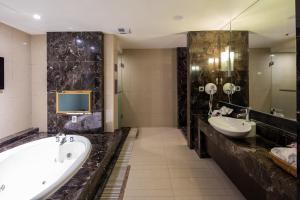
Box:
[208,117,251,138]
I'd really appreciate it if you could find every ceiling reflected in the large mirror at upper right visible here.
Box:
[229,0,296,48]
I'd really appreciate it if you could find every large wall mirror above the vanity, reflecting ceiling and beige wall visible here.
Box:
[225,0,296,120]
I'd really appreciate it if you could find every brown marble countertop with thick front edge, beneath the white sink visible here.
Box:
[196,115,297,199]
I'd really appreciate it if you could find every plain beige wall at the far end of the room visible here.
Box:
[122,49,177,127]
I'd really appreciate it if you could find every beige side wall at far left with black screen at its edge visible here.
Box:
[0,23,32,138]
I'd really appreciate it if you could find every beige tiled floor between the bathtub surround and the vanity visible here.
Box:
[124,128,245,200]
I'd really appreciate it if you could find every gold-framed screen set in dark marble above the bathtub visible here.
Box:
[56,90,92,115]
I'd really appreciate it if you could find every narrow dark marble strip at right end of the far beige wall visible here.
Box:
[177,47,188,129]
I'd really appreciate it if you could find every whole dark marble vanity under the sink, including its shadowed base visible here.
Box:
[195,115,297,200]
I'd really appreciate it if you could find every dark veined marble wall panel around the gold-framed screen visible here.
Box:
[47,32,104,133]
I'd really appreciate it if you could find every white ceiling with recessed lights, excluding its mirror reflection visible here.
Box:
[0,0,258,48]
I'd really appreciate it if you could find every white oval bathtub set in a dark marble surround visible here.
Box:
[0,135,91,200]
